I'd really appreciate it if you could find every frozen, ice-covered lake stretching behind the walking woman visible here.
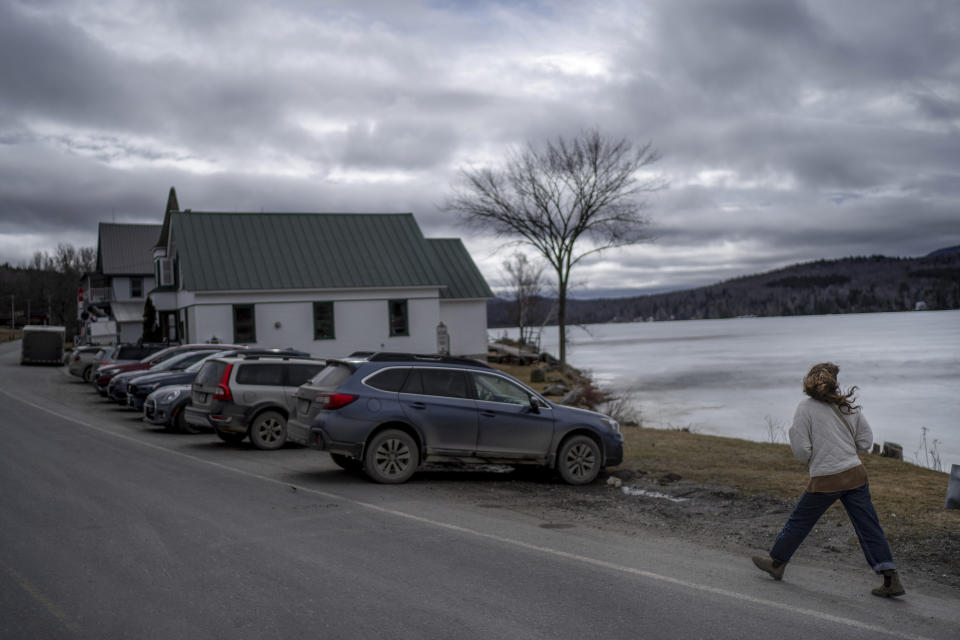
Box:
[490,311,960,471]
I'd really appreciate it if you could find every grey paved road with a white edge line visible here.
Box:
[0,343,960,640]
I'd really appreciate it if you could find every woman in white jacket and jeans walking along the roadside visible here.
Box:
[753,362,906,598]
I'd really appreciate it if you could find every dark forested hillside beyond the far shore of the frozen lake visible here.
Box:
[487,252,960,327]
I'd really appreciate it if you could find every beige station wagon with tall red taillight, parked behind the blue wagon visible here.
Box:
[184,355,326,450]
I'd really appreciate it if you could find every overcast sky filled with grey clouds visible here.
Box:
[0,0,960,293]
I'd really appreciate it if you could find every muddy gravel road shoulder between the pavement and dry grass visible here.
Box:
[414,467,960,595]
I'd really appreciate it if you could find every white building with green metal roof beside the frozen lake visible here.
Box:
[150,196,493,357]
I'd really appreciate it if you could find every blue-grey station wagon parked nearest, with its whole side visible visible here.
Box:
[287,353,623,484]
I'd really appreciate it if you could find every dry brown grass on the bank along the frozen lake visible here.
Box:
[494,356,960,542]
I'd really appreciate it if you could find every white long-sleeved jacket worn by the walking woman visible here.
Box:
[790,398,873,478]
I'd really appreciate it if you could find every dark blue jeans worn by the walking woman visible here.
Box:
[770,484,896,573]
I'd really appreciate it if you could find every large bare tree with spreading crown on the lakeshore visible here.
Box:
[445,130,666,365]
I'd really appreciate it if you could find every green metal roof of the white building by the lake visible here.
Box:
[167,211,493,299]
